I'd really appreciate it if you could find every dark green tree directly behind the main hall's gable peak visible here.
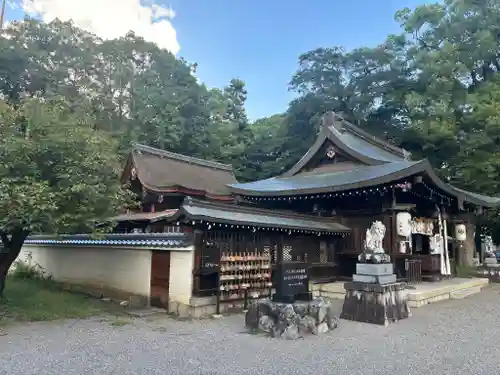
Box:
[282,36,412,170]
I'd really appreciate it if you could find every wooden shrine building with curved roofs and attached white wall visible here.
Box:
[23,113,500,316]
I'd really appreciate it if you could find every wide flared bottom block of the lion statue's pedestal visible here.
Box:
[340,282,411,326]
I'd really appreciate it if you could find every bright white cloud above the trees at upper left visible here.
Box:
[22,0,180,54]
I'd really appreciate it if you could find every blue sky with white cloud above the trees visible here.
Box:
[6,0,436,120]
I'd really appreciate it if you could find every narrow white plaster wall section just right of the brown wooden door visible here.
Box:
[169,249,194,305]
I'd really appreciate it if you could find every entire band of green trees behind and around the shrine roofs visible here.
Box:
[0,0,500,282]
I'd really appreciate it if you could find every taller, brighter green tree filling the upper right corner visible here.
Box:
[390,0,500,178]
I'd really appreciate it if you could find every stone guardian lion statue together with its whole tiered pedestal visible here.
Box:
[340,221,411,325]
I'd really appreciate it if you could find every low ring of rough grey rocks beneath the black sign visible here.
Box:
[245,297,338,340]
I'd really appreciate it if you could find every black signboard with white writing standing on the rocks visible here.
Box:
[273,262,309,302]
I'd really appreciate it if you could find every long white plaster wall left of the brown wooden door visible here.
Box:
[18,245,151,296]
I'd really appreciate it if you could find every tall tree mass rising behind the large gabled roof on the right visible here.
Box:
[285,0,500,241]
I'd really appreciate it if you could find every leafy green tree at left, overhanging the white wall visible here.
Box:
[0,99,134,296]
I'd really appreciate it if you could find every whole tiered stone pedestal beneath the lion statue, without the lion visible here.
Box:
[340,263,411,326]
